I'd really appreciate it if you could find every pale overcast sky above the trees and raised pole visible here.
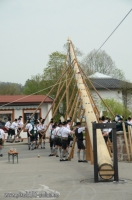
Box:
[0,0,132,85]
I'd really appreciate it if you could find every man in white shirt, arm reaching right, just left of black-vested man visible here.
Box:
[60,121,74,161]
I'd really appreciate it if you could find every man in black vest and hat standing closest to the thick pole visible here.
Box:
[75,122,87,162]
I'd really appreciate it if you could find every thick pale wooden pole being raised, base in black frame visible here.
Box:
[68,40,113,178]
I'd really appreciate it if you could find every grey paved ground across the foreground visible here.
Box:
[0,143,132,200]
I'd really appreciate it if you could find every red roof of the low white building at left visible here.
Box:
[0,95,53,104]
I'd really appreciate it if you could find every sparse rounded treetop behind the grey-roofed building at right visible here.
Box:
[82,50,124,80]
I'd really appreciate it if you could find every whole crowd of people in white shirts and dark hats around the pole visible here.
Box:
[0,114,132,159]
